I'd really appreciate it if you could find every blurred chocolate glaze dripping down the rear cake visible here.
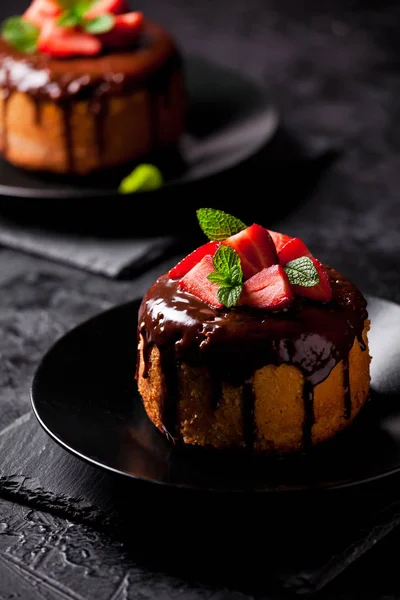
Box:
[0,21,181,169]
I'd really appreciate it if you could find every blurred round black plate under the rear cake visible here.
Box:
[0,58,278,199]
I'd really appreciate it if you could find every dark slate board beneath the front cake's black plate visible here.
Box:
[0,413,400,597]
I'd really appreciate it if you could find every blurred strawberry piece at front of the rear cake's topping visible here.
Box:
[38,21,103,58]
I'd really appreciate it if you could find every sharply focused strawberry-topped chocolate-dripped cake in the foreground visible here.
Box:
[136,209,370,454]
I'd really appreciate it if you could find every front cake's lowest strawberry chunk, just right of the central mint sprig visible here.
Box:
[239,265,293,310]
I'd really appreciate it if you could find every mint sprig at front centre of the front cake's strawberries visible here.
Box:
[207,246,243,308]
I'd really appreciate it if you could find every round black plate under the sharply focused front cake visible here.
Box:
[32,297,400,492]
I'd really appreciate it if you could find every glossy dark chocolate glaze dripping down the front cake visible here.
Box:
[138,267,368,449]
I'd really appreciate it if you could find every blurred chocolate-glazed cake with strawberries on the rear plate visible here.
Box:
[0,0,185,175]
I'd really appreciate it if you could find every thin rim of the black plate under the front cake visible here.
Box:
[30,294,400,495]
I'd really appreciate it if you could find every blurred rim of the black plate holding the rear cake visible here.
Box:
[0,54,281,201]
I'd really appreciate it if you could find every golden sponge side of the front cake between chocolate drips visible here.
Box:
[138,321,370,454]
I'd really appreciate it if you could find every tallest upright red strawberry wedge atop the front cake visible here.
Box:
[222,224,279,279]
